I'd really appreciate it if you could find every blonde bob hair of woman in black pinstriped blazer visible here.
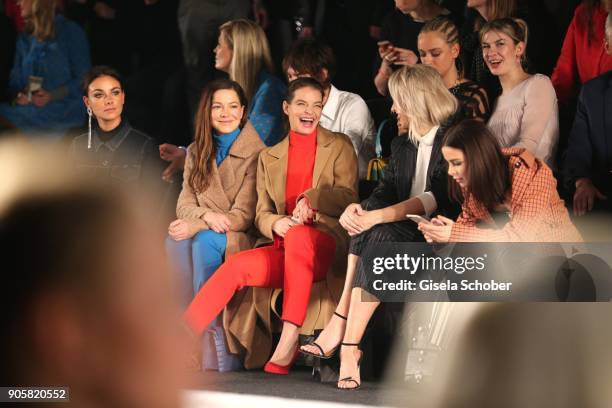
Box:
[389,64,459,144]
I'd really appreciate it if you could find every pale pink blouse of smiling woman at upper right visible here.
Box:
[489,74,559,168]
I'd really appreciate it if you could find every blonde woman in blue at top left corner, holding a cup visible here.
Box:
[0,0,91,133]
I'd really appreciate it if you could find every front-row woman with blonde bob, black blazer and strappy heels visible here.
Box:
[301,65,461,389]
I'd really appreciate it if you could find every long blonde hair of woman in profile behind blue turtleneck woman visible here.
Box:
[219,19,273,101]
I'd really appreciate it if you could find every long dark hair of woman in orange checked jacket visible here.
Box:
[442,119,511,211]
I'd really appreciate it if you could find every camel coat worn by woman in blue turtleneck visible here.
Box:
[176,122,266,256]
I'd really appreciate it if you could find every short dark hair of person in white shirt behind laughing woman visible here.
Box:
[283,38,336,86]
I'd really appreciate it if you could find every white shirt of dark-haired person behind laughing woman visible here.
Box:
[320,85,376,179]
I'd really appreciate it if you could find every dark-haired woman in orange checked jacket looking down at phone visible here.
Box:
[419,120,582,243]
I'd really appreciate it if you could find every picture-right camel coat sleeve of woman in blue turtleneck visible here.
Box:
[227,153,259,231]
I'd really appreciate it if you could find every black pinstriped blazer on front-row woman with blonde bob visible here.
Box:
[362,112,463,219]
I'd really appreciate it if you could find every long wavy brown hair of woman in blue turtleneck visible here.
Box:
[189,79,249,192]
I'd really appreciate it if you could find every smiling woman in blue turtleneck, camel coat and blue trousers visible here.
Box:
[166,80,265,305]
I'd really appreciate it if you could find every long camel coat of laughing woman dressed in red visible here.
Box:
[224,127,358,368]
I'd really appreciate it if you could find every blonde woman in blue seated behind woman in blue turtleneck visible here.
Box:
[160,19,287,178]
